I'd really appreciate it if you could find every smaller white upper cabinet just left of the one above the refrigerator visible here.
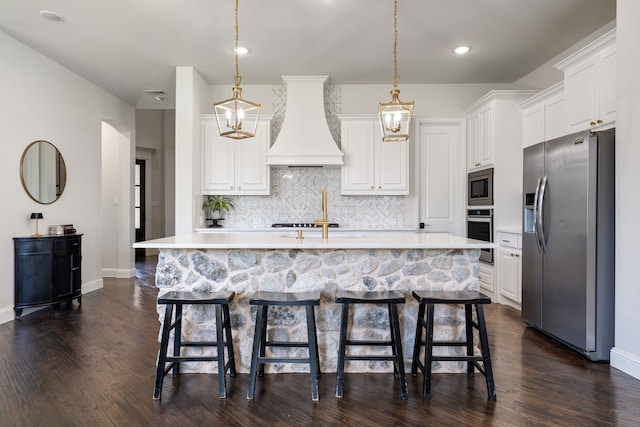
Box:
[519,82,567,148]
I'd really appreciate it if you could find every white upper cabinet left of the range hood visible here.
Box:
[202,114,271,195]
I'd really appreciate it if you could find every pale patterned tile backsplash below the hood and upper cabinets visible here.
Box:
[194,167,406,229]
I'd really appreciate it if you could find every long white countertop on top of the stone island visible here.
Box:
[133,234,498,249]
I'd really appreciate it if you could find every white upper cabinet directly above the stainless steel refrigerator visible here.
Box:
[555,29,616,133]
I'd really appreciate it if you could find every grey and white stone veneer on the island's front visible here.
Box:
[156,249,480,373]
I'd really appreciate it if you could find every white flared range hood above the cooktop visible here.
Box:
[267,76,344,166]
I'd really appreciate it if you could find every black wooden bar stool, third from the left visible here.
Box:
[336,291,408,399]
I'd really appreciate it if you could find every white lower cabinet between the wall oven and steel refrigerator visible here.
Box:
[496,232,522,309]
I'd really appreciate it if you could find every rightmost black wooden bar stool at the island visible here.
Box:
[411,291,496,400]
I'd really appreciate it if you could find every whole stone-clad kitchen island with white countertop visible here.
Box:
[134,230,497,373]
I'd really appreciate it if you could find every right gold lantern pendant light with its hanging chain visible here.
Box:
[378,0,413,142]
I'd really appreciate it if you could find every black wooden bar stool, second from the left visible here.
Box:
[247,291,320,400]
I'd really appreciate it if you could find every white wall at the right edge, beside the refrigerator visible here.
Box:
[611,0,640,379]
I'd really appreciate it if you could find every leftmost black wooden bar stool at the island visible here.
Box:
[153,291,236,400]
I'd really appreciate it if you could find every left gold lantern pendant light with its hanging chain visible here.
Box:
[213,0,260,139]
